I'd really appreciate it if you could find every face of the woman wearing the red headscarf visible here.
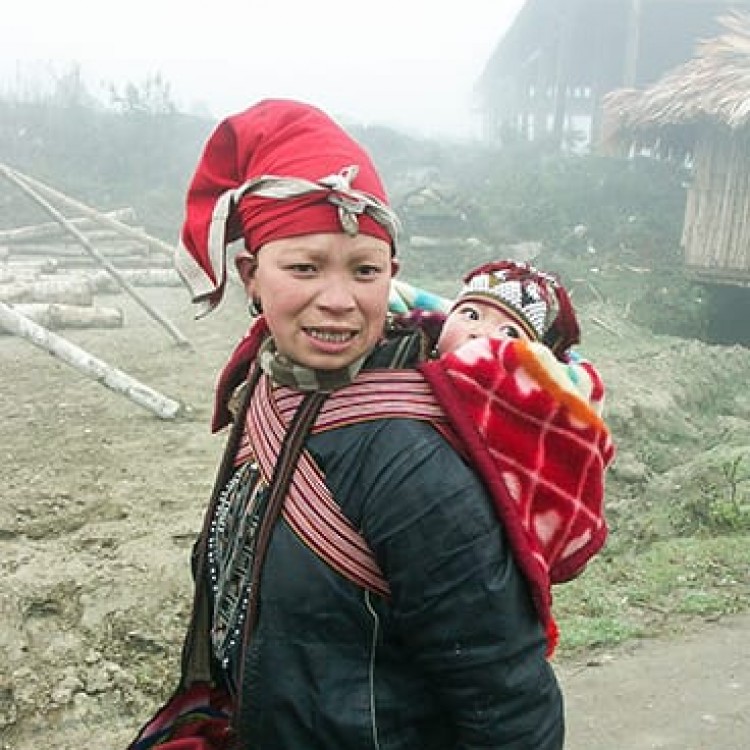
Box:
[243,233,397,370]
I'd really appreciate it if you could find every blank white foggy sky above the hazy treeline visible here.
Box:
[0,0,524,138]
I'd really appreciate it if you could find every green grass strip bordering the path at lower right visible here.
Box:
[553,534,750,657]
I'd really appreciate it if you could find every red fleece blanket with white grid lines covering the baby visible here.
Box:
[421,339,614,622]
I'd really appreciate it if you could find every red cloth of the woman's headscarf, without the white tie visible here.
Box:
[181,99,391,283]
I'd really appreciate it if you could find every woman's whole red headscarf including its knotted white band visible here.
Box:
[175,99,399,312]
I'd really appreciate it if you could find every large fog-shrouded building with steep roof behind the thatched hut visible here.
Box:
[475,0,750,150]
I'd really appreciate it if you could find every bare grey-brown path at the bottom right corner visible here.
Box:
[558,615,750,750]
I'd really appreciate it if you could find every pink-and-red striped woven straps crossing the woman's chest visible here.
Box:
[235,370,447,597]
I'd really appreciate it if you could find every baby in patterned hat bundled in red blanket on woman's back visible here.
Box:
[422,261,614,650]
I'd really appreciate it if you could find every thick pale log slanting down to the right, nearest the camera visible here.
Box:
[0,302,184,419]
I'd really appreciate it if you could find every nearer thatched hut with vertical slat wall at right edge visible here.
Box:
[603,13,750,286]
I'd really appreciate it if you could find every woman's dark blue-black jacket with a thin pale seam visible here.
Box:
[232,419,563,750]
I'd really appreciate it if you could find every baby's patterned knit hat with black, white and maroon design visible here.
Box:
[453,260,580,359]
